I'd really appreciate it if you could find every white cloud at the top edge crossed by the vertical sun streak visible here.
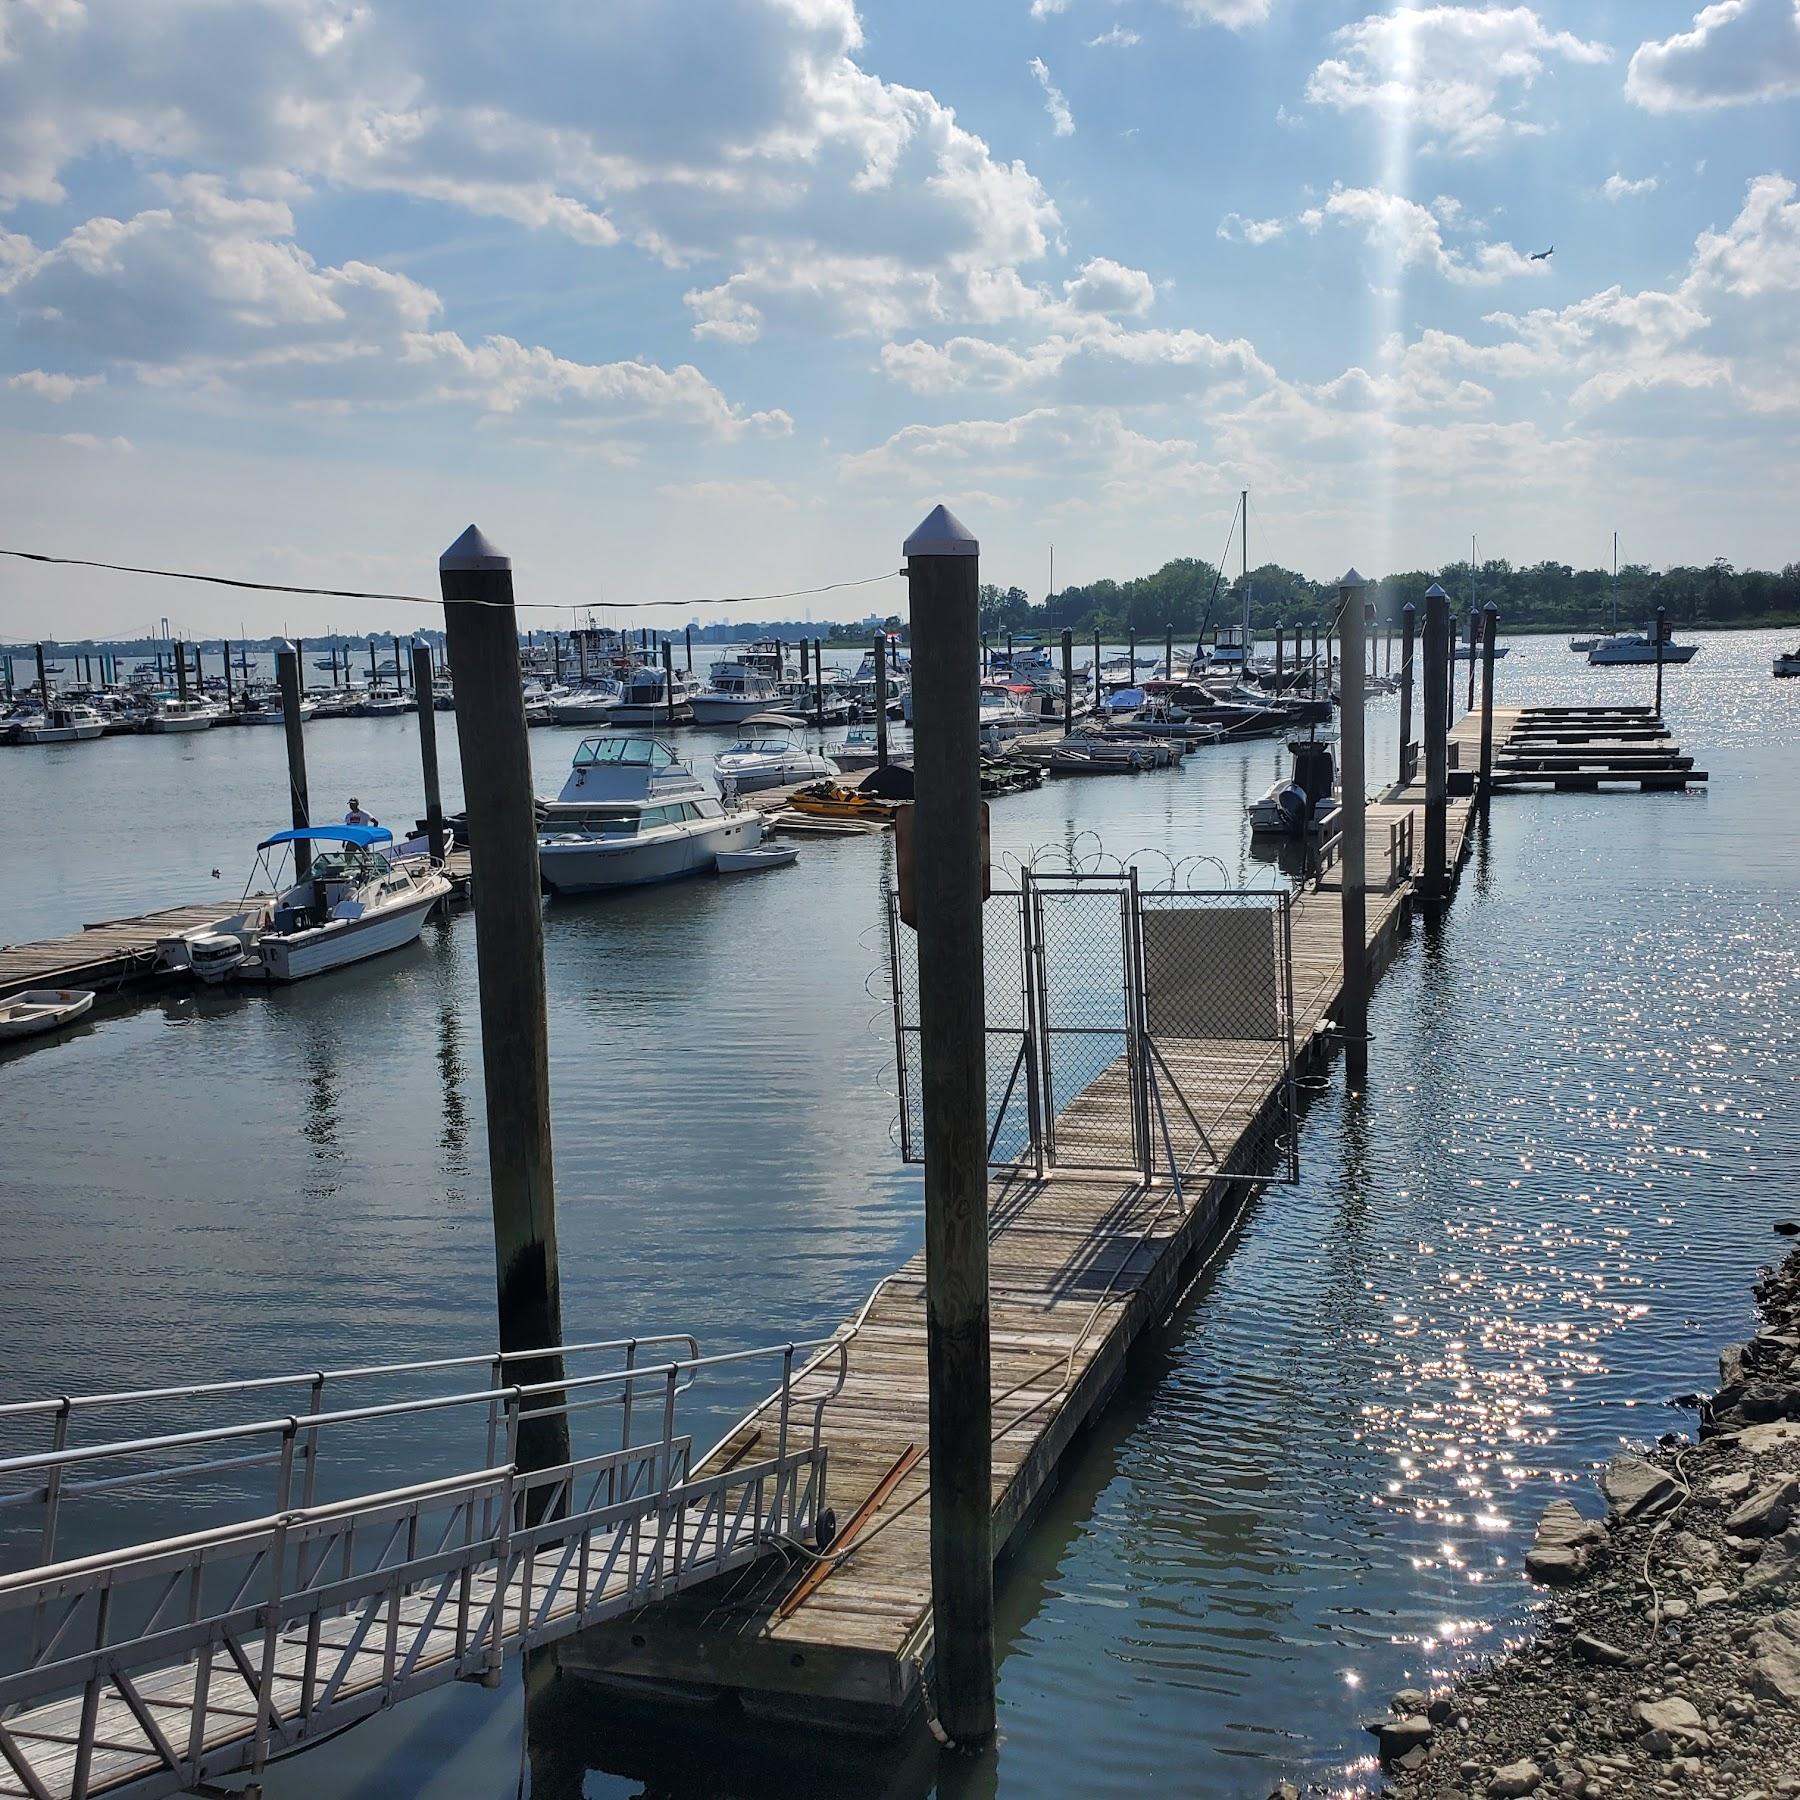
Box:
[1307,5,1613,157]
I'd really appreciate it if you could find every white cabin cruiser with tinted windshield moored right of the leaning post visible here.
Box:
[538,733,763,895]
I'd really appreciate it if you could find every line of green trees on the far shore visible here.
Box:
[981,556,1800,641]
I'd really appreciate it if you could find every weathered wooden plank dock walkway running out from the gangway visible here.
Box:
[560,709,1490,1733]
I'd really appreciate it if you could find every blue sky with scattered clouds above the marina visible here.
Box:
[0,0,1800,637]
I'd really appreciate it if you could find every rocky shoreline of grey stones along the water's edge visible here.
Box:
[1324,1226,1800,1800]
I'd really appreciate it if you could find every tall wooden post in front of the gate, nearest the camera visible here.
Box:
[905,506,993,1744]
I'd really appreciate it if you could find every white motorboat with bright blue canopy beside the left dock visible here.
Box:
[157,824,450,985]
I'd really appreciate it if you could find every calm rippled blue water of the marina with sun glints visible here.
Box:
[0,634,1800,1800]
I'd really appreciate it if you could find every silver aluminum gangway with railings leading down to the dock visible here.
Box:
[0,1336,846,1800]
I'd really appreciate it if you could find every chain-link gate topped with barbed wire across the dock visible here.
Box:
[887,869,1300,1183]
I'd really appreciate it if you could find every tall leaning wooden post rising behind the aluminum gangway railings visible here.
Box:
[437,526,569,1469]
